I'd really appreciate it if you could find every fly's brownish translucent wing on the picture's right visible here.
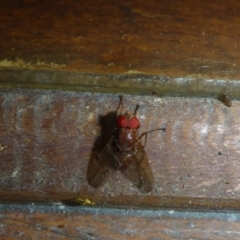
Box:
[122,142,154,193]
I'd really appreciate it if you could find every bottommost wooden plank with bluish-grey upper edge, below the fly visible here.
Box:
[0,205,240,240]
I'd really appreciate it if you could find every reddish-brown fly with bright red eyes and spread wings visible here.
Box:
[88,96,166,193]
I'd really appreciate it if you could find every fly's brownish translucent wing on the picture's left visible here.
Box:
[87,137,113,188]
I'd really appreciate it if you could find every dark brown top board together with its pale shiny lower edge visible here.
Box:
[0,0,240,99]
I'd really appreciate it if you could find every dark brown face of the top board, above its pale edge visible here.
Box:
[0,0,240,80]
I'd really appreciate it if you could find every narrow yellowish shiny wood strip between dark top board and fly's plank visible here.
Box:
[0,69,240,100]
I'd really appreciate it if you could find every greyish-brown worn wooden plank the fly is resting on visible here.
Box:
[0,90,240,209]
